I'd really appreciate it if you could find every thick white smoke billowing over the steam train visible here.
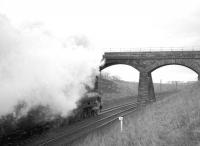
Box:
[0,16,101,116]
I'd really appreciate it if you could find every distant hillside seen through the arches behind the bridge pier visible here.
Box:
[99,79,186,101]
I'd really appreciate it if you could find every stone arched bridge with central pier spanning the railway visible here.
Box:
[100,51,200,103]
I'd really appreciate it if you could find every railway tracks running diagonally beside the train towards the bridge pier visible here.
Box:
[25,102,137,146]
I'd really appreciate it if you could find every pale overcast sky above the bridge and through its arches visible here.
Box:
[0,0,200,81]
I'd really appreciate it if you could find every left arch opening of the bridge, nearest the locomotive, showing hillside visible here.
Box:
[99,64,139,102]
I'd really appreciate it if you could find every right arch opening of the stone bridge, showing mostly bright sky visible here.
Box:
[152,65,198,93]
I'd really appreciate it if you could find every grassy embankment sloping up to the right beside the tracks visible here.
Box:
[72,83,200,146]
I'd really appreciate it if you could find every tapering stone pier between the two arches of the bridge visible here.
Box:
[137,72,156,104]
